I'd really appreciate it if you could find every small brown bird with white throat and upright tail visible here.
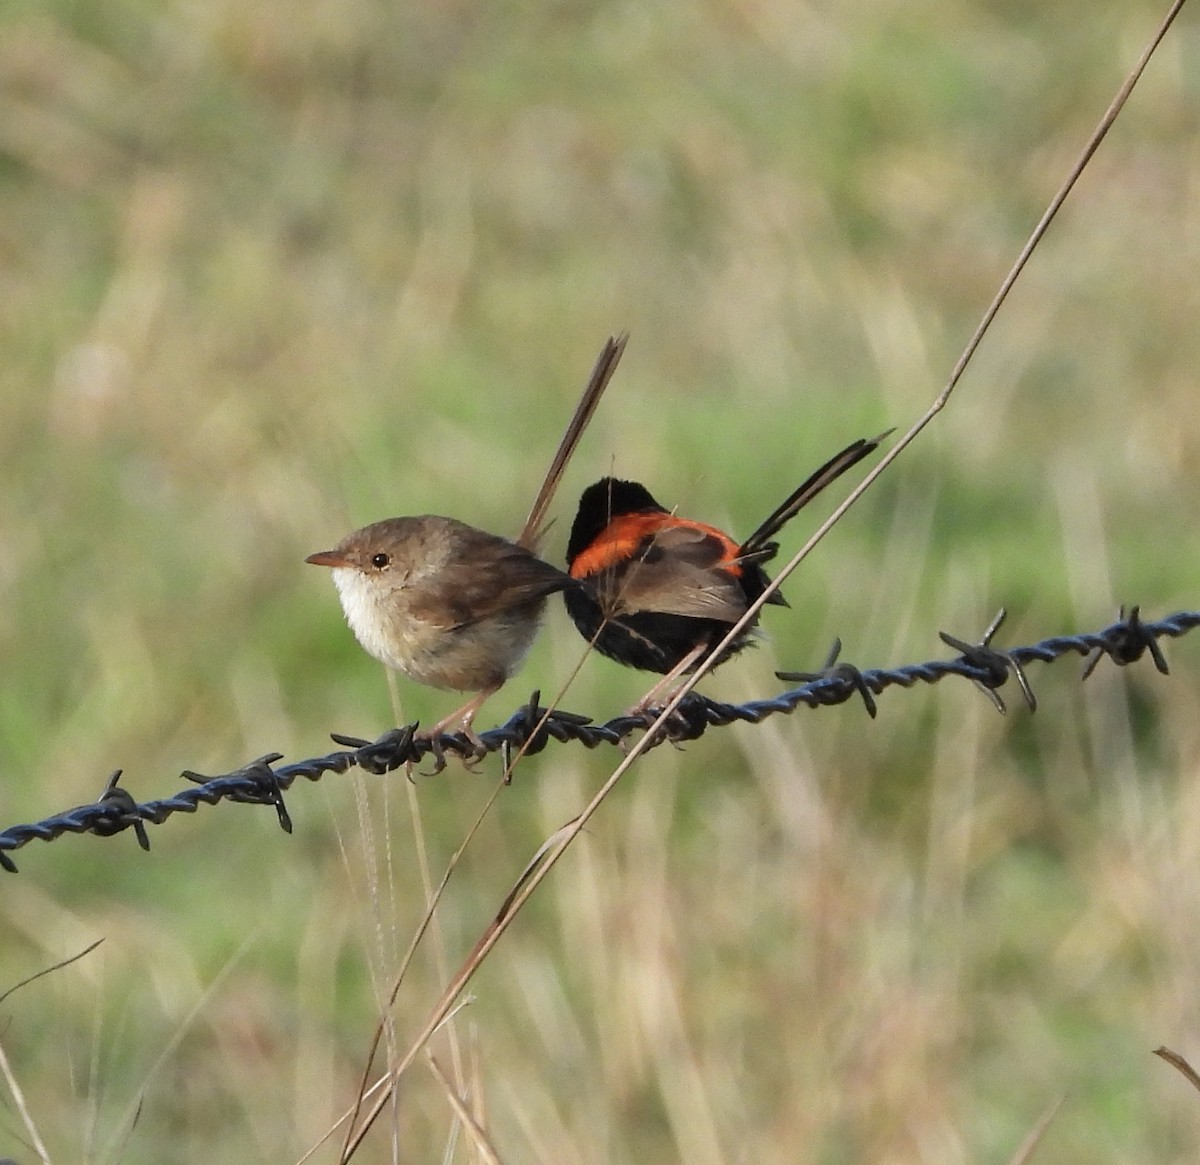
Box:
[305,332,629,737]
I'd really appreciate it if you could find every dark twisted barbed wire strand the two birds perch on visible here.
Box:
[0,607,1200,873]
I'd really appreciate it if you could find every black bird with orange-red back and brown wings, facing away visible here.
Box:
[563,430,892,707]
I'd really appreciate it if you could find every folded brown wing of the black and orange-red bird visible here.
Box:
[598,526,746,623]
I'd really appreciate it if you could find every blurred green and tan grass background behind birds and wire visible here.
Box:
[0,0,1200,1165]
